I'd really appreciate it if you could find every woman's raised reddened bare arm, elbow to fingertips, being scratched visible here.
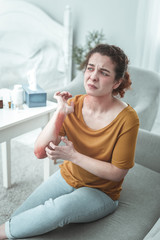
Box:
[34,92,74,158]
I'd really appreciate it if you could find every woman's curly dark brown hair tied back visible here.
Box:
[81,44,132,98]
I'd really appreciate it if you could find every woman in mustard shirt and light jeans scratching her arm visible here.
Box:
[0,44,139,239]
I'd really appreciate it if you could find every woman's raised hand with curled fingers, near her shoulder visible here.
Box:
[54,91,74,114]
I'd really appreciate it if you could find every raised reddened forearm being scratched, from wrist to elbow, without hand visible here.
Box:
[34,109,67,158]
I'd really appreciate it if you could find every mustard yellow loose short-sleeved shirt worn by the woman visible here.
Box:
[59,95,139,200]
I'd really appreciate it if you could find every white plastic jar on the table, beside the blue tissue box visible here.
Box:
[12,84,24,108]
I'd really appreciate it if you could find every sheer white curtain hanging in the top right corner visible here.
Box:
[135,0,160,73]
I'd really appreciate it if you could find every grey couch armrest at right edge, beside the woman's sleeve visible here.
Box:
[135,128,160,173]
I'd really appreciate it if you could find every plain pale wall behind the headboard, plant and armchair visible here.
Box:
[26,0,139,65]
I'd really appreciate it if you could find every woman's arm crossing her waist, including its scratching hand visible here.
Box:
[46,137,128,182]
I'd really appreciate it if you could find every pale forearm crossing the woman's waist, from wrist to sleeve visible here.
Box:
[72,152,128,182]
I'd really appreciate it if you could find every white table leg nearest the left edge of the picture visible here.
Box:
[1,140,11,188]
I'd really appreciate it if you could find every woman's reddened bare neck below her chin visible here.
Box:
[84,95,115,112]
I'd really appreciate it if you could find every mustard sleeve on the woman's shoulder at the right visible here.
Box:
[111,123,139,169]
